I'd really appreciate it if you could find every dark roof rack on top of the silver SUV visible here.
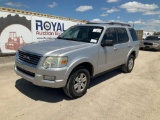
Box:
[86,22,131,27]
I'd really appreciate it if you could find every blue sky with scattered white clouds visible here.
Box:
[0,0,160,32]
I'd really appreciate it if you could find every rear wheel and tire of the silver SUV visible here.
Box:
[122,55,135,73]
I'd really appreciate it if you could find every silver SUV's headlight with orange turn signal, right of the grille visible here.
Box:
[43,57,68,68]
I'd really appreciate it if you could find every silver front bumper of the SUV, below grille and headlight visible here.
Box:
[14,60,67,88]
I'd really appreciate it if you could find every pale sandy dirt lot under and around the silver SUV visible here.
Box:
[0,51,160,120]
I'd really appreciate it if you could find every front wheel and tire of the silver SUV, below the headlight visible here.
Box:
[63,68,90,98]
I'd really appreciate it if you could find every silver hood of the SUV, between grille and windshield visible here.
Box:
[19,39,93,55]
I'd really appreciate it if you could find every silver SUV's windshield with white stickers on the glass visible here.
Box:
[57,26,103,43]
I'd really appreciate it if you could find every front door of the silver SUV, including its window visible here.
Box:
[98,28,121,72]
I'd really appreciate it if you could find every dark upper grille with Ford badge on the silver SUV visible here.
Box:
[18,51,41,65]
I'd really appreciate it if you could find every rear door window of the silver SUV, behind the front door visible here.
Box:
[116,28,129,43]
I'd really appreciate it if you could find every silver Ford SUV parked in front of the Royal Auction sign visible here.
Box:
[15,22,139,98]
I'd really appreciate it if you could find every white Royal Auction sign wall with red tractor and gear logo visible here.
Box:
[0,7,87,54]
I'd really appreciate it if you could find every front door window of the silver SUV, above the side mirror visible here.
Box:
[103,28,117,44]
